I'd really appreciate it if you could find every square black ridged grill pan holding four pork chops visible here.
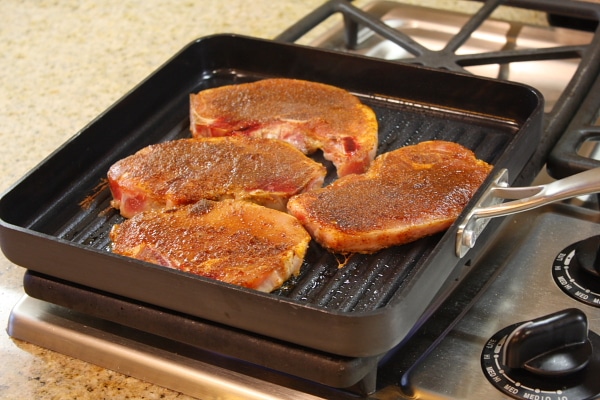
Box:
[0,35,543,357]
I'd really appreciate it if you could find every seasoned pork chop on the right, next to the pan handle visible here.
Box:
[288,141,492,253]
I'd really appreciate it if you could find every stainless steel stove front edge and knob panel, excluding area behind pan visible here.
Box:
[9,174,600,399]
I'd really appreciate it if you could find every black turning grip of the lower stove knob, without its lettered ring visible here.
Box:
[502,308,592,376]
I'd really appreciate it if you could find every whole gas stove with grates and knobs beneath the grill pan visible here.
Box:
[8,1,600,400]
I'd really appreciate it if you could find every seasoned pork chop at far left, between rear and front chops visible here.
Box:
[108,137,327,218]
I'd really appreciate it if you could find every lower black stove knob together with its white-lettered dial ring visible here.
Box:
[481,308,600,400]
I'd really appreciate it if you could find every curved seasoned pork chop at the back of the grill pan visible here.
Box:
[190,79,377,176]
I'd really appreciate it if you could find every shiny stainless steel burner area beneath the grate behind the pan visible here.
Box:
[311,1,593,112]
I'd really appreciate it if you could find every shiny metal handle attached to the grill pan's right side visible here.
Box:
[456,167,600,257]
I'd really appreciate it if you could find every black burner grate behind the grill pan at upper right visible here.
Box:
[277,0,600,181]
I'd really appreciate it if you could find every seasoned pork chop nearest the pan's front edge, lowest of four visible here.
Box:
[110,200,310,292]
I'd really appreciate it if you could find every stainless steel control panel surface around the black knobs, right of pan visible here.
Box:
[403,190,600,399]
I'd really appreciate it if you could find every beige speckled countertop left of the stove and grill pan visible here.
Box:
[0,0,548,399]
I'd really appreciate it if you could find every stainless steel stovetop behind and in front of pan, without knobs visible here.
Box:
[8,1,600,400]
